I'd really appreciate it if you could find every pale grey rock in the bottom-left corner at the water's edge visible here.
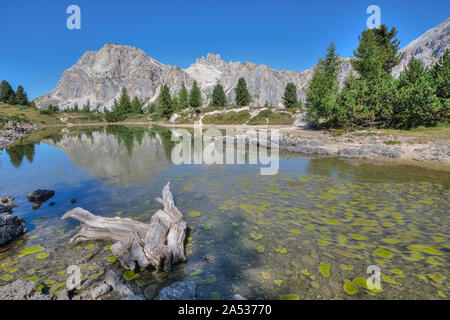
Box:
[0,279,56,300]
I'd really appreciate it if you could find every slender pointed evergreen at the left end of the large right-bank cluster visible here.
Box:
[306,42,340,121]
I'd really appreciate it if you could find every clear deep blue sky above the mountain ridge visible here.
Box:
[0,0,450,98]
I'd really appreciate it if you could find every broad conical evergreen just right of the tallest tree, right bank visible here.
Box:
[394,57,442,129]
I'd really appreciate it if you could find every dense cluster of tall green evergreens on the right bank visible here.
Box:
[305,25,450,129]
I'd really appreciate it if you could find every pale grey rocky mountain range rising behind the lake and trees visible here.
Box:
[35,18,450,109]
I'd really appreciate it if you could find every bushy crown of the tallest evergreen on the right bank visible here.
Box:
[352,24,401,80]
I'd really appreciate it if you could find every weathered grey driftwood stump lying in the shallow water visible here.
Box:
[62,182,187,271]
